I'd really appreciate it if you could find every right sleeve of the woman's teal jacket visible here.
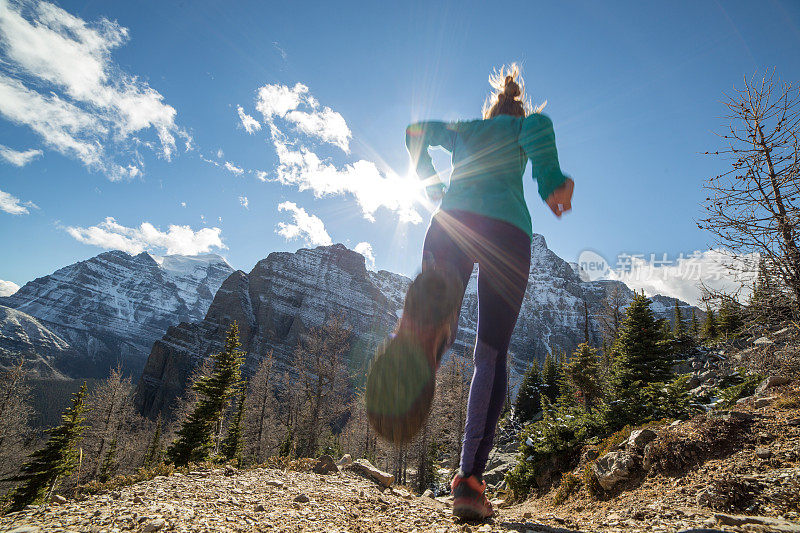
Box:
[519,113,567,200]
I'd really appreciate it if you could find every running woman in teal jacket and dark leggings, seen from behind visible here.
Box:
[367,64,574,519]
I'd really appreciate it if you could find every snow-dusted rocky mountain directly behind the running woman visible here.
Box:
[137,239,689,416]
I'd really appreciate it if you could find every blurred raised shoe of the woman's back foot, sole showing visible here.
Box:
[366,269,464,443]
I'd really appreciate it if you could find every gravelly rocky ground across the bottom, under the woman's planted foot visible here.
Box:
[0,385,800,533]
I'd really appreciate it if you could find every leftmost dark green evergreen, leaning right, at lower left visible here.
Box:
[8,382,86,511]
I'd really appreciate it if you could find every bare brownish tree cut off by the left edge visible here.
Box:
[0,357,33,488]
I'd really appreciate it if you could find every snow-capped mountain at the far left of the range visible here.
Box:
[0,251,233,378]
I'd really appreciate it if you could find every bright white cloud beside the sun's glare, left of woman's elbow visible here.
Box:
[271,125,422,224]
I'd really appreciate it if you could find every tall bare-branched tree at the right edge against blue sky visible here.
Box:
[698,68,800,311]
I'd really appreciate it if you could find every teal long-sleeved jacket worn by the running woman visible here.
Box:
[406,113,567,235]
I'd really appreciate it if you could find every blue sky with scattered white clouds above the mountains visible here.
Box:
[0,0,800,304]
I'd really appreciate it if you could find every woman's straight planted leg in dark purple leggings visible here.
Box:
[461,221,530,477]
